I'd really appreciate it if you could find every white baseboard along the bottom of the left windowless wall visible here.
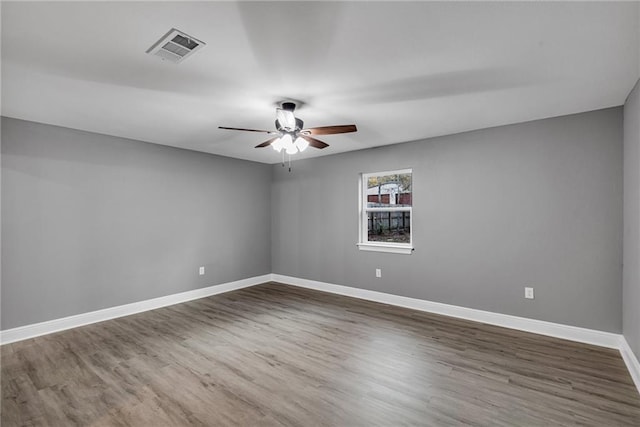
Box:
[0,274,271,344]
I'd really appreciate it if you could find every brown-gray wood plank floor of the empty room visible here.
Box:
[1,284,640,427]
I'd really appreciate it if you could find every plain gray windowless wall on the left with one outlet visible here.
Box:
[1,118,271,329]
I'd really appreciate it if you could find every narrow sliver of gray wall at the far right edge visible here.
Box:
[622,81,640,358]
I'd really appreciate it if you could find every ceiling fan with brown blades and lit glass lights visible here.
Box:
[218,102,358,155]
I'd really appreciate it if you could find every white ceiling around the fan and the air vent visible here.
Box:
[1,2,640,163]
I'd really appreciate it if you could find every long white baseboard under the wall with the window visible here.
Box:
[271,274,621,349]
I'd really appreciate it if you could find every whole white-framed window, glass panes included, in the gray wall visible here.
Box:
[358,169,413,254]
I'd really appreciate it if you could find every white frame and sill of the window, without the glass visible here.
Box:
[357,169,413,255]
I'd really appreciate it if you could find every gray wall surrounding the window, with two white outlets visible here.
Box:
[271,108,622,333]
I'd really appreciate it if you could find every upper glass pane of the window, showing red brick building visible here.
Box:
[367,173,411,208]
